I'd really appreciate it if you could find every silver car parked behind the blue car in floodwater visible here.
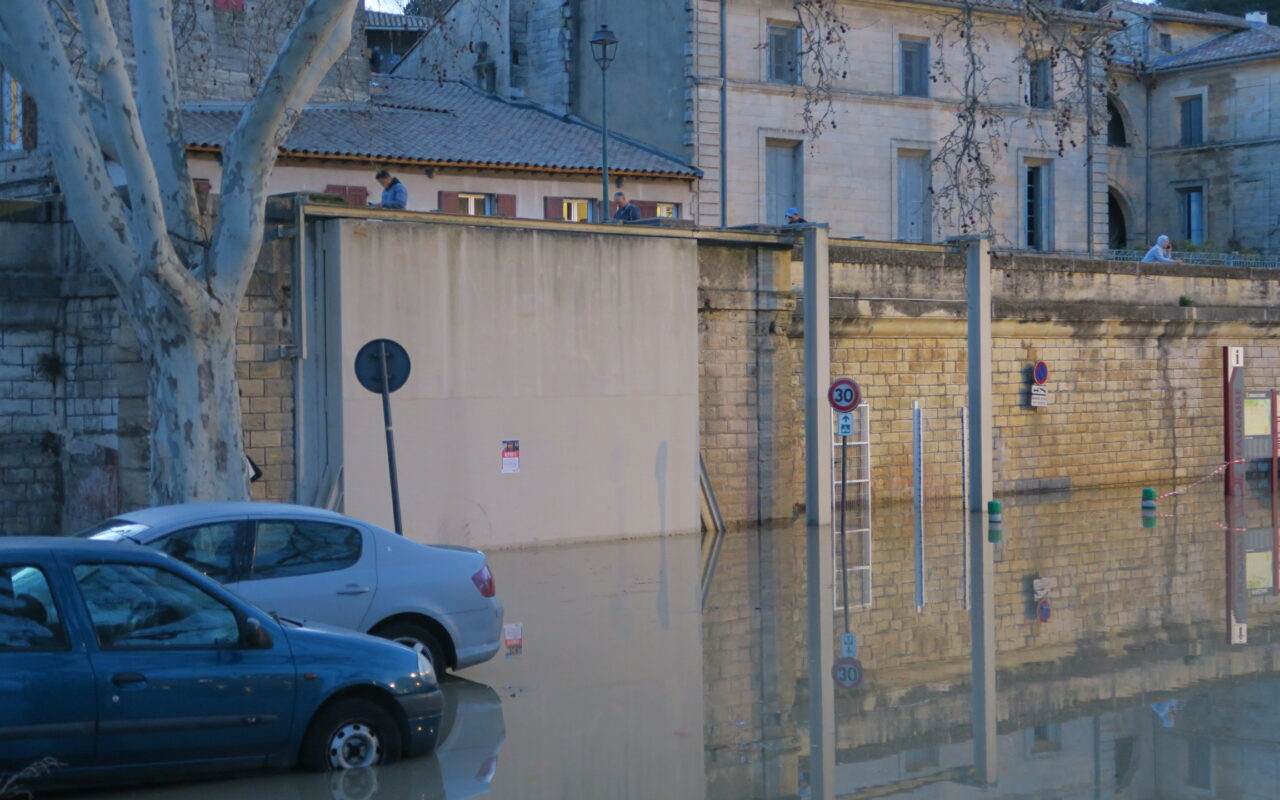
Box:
[77,503,503,671]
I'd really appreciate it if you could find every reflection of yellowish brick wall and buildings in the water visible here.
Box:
[704,483,1280,800]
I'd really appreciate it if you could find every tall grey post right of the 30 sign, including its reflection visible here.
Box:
[965,237,1000,783]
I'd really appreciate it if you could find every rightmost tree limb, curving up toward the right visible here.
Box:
[204,0,360,305]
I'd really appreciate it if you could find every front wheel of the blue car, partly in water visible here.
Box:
[298,698,403,772]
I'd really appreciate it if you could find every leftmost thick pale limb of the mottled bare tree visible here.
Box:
[0,3,138,288]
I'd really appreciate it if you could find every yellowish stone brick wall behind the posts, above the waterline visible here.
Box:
[699,241,1280,522]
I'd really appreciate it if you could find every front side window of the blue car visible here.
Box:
[74,563,239,649]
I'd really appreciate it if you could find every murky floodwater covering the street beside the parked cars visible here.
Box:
[45,471,1280,800]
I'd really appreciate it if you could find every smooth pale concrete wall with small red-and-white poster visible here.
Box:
[311,213,698,548]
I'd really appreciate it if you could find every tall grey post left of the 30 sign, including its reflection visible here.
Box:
[804,225,836,800]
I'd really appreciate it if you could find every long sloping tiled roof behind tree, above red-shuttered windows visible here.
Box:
[183,76,700,178]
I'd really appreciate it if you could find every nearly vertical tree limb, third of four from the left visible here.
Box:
[129,0,204,252]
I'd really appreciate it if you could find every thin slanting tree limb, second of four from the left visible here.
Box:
[76,0,201,303]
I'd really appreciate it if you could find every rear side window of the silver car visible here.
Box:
[250,520,361,580]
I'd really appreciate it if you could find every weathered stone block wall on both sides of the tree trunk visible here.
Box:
[0,206,293,535]
